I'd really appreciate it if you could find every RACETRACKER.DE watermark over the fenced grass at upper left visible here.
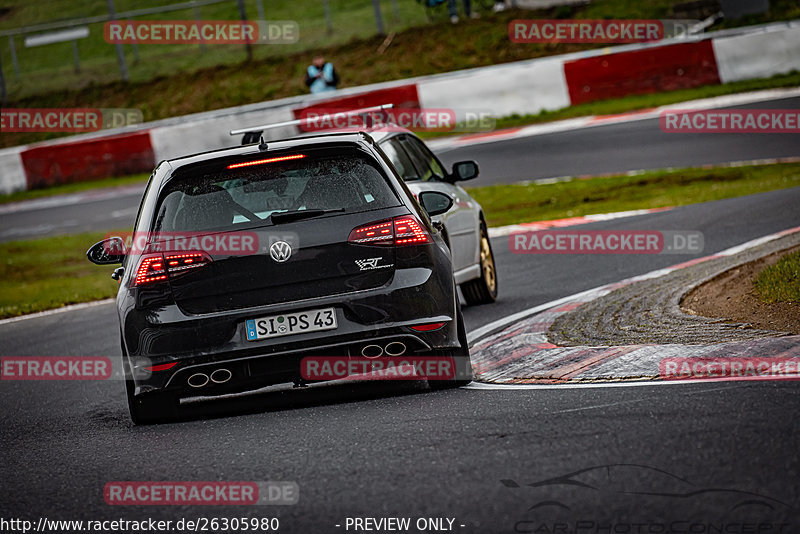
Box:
[103,20,300,44]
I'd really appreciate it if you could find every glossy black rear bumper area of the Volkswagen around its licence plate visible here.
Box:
[118,267,460,395]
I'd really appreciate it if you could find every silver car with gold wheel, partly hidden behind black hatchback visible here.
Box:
[369,128,497,305]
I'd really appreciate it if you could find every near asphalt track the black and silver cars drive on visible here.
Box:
[0,188,800,533]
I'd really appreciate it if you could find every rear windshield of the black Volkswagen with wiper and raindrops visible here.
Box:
[153,148,400,232]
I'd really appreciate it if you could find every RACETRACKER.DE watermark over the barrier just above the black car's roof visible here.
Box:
[298,108,497,132]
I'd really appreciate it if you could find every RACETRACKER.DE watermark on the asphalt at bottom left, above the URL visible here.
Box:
[103,481,300,506]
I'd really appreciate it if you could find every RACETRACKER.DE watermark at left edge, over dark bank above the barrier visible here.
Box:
[0,108,144,133]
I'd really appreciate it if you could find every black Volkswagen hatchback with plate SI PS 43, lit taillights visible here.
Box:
[87,132,472,423]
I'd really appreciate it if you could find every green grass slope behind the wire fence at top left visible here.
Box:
[0,0,426,95]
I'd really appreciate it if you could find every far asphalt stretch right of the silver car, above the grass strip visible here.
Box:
[441,98,800,186]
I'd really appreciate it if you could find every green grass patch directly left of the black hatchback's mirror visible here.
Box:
[0,232,118,318]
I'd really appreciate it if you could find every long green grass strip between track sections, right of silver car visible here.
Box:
[468,163,800,226]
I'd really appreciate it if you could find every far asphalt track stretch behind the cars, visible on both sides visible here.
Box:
[0,97,800,241]
